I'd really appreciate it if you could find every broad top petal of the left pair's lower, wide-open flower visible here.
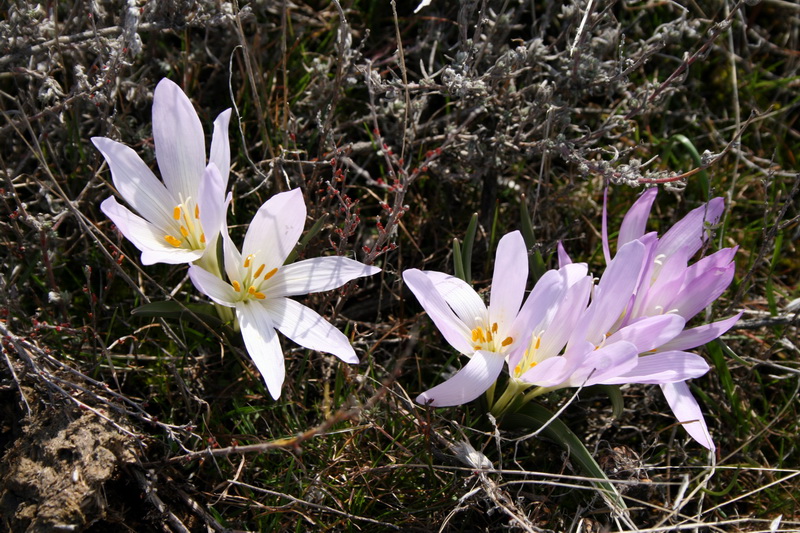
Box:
[242,189,306,270]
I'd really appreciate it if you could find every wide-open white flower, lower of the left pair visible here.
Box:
[189,189,380,399]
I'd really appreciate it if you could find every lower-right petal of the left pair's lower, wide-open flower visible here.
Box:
[263,298,358,364]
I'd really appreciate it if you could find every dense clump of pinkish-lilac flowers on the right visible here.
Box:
[410,189,740,450]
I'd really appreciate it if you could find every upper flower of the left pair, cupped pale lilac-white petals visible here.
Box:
[92,79,231,270]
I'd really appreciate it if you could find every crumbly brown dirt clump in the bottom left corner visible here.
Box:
[0,407,135,532]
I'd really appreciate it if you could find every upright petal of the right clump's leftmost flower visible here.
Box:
[489,231,528,324]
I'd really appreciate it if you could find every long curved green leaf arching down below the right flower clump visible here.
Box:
[500,402,627,509]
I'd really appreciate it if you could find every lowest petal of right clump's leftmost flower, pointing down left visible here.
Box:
[417,350,505,407]
